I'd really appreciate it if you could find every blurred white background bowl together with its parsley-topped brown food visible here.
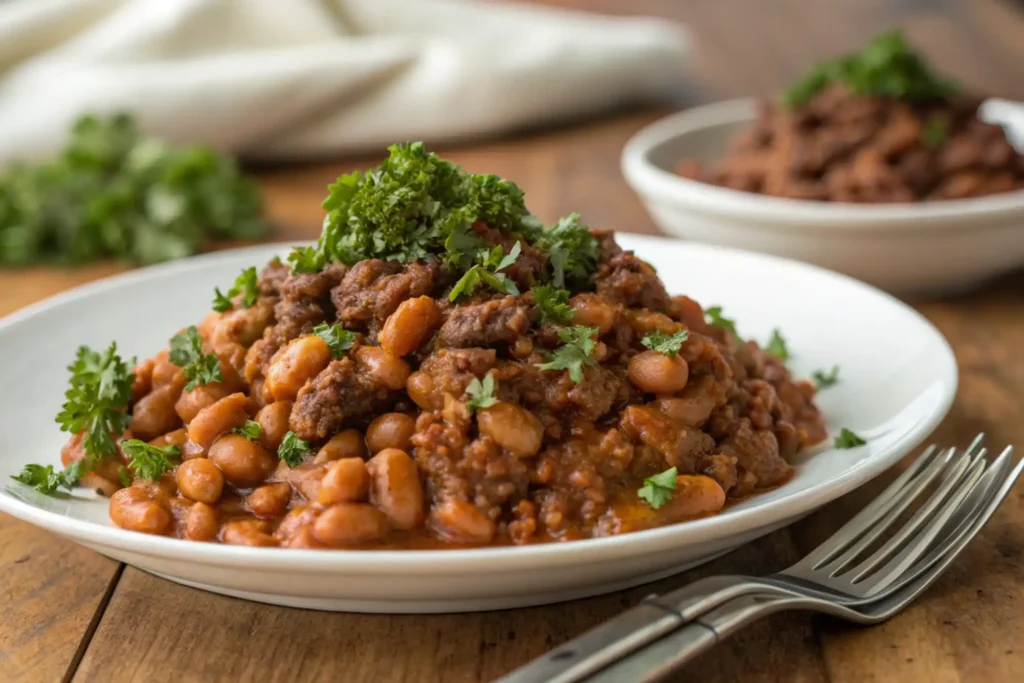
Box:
[623,32,1024,294]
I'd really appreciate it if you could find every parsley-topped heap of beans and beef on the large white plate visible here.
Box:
[17,143,831,548]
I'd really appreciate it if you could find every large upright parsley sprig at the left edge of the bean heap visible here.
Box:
[56,343,135,471]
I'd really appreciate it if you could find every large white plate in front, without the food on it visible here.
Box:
[0,236,956,612]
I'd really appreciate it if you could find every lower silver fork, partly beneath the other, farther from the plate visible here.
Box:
[586,449,1024,683]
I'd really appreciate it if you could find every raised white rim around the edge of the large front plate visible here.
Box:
[0,237,959,577]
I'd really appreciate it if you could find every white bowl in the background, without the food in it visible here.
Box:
[622,99,1024,295]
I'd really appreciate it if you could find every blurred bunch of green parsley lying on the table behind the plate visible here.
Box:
[0,115,267,266]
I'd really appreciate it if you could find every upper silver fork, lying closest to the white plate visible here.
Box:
[500,435,1003,683]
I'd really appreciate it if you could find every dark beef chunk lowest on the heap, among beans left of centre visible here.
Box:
[289,357,397,441]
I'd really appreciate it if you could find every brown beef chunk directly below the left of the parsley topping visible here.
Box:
[331,259,440,338]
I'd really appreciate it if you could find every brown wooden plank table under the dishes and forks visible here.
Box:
[0,0,1024,683]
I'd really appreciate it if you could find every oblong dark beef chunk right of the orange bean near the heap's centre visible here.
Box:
[434,296,529,348]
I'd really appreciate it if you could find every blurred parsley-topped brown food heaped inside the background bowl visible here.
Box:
[677,33,1024,203]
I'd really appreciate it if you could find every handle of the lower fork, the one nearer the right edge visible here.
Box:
[585,593,808,683]
